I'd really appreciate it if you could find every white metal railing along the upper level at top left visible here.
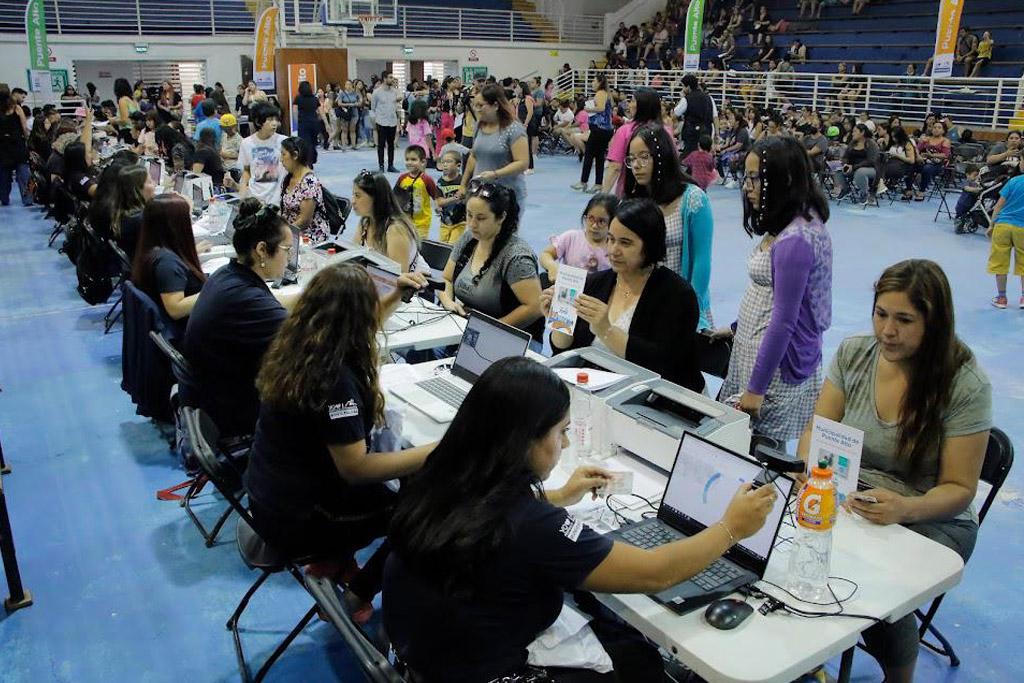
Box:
[0,0,604,46]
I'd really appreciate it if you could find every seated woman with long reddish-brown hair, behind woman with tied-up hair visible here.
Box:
[131,194,206,340]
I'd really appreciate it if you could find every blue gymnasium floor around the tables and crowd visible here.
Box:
[0,151,1024,683]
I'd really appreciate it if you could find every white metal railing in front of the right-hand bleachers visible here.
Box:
[556,69,1024,128]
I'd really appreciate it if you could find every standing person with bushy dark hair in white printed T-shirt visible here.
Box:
[239,102,285,204]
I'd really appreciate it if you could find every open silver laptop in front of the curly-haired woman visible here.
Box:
[391,310,530,423]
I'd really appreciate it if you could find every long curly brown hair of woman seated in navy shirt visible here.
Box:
[256,263,384,425]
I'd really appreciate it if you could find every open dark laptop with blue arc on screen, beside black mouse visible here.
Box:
[608,432,794,614]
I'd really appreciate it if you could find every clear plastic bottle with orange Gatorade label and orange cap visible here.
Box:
[788,460,836,602]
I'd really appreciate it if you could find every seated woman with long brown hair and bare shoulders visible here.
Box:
[352,171,430,272]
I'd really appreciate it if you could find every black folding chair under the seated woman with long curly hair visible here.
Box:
[183,408,316,683]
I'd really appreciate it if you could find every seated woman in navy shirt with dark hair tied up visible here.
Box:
[182,198,293,437]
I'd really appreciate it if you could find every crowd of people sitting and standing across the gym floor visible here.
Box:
[0,57,1007,682]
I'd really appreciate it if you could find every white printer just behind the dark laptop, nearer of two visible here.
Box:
[606,379,751,472]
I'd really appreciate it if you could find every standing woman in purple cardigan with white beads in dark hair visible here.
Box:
[720,137,831,440]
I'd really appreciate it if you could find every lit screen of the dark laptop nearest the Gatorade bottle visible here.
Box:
[662,432,793,564]
